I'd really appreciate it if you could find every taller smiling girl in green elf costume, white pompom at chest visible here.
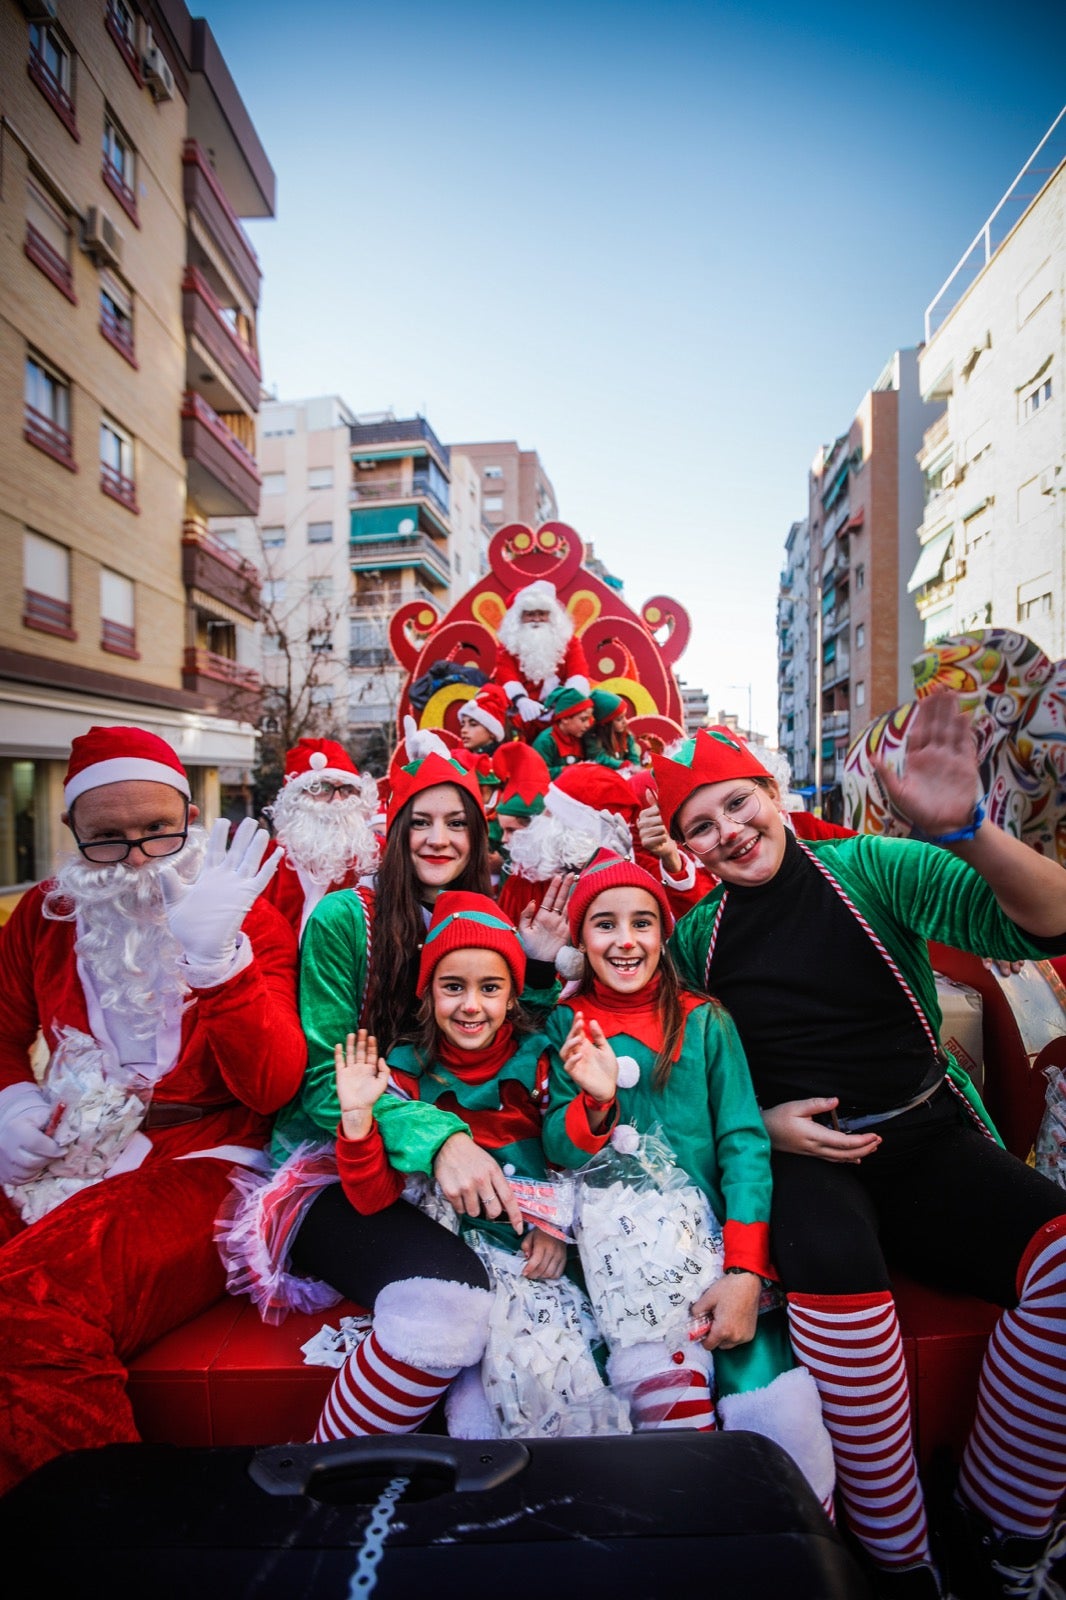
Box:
[544,850,832,1510]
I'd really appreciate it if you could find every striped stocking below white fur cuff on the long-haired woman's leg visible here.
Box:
[315,1328,459,1445]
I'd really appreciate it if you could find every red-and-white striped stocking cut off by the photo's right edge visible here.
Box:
[959,1216,1066,1539]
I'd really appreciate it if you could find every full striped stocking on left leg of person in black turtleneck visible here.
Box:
[789,1290,930,1568]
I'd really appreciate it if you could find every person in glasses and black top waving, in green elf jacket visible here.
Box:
[659,693,1066,1597]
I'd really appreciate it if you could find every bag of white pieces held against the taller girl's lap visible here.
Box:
[575,1126,725,1350]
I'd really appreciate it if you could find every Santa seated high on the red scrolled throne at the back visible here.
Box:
[493,579,589,733]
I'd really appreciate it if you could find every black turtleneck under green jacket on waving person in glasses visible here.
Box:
[711,832,933,1115]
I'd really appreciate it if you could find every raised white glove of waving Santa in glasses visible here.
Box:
[158,816,282,968]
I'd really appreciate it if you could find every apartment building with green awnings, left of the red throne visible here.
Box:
[349,411,451,765]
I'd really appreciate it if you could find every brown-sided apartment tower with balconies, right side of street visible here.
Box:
[808,349,936,789]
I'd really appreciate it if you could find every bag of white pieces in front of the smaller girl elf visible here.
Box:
[469,1234,632,1438]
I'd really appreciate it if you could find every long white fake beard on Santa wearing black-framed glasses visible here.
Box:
[43,827,206,1040]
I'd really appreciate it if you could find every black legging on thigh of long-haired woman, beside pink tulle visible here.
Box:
[291,1184,488,1310]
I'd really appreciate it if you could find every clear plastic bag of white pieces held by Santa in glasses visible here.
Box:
[3,1027,152,1222]
